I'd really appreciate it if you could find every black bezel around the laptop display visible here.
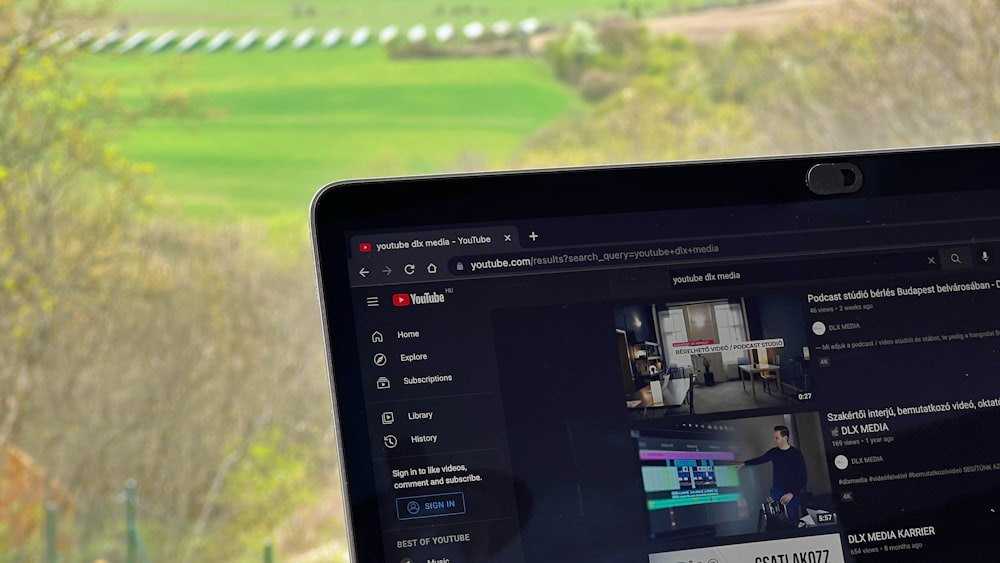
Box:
[310,145,1000,560]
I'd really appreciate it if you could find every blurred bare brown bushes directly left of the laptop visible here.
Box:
[17,221,335,561]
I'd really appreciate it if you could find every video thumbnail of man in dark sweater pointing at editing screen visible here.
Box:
[632,412,837,541]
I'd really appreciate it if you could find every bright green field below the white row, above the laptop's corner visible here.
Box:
[80,48,579,219]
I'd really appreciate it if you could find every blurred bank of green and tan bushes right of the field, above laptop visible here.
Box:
[517,0,1000,166]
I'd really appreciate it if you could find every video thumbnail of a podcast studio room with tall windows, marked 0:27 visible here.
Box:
[615,295,812,419]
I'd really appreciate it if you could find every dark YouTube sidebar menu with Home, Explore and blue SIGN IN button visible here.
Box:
[356,286,523,563]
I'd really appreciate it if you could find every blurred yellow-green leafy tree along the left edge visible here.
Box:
[0,0,144,478]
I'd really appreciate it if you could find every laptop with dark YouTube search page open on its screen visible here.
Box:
[311,146,1000,563]
